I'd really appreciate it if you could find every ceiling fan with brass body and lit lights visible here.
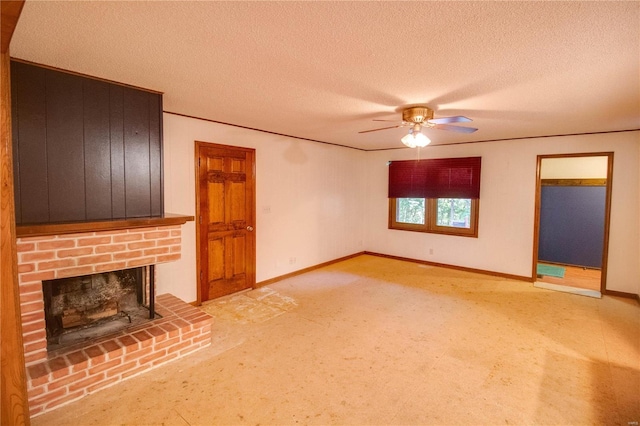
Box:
[358,106,478,148]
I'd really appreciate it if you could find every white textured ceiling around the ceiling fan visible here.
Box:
[11,0,640,150]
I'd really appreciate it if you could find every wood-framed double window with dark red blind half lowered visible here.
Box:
[389,157,480,237]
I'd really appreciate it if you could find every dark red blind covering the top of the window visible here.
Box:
[389,157,482,199]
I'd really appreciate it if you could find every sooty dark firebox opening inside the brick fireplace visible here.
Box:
[42,266,155,351]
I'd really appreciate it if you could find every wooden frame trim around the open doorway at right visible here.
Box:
[531,152,613,295]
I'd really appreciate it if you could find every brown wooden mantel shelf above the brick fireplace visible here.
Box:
[16,213,194,237]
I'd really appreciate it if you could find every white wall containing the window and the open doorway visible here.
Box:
[366,132,640,294]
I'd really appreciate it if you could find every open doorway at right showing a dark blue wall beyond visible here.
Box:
[532,152,613,297]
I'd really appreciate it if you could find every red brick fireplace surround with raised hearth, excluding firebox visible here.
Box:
[17,221,212,416]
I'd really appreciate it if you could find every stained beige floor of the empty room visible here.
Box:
[32,256,640,426]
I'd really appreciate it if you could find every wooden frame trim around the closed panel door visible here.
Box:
[194,140,257,306]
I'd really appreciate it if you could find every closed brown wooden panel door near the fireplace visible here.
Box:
[196,142,255,302]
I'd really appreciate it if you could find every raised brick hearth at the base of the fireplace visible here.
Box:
[27,294,212,416]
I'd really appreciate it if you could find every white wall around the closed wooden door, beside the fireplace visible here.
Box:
[157,114,366,302]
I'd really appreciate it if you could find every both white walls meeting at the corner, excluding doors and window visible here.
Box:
[158,118,640,302]
